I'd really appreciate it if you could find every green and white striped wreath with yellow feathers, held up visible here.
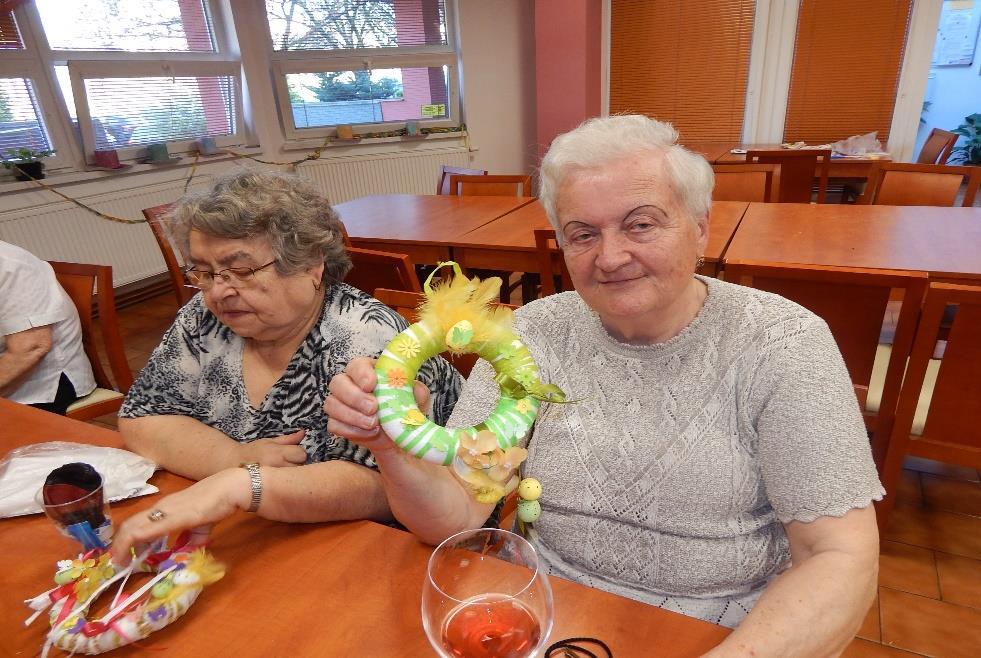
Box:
[375,262,565,503]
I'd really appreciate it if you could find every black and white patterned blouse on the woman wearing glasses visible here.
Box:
[119,284,462,468]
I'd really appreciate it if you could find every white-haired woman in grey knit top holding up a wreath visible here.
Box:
[325,116,883,656]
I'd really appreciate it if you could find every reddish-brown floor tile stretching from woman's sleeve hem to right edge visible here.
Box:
[883,505,981,559]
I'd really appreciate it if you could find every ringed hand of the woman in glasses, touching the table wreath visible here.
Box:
[111,468,251,564]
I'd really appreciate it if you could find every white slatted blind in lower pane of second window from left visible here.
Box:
[85,76,235,149]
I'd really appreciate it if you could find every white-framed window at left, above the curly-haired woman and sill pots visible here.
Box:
[7,0,244,162]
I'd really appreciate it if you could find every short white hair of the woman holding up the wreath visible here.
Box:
[538,114,715,233]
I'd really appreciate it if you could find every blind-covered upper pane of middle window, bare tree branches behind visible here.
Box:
[266,0,447,50]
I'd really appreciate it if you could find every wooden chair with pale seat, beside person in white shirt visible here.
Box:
[48,261,133,420]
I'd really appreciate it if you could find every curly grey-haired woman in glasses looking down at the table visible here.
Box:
[109,171,461,552]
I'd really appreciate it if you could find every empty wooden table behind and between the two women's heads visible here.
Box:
[334,194,534,265]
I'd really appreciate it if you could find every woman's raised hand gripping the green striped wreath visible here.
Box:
[324,358,430,457]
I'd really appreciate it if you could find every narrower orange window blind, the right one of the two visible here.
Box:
[783,0,913,144]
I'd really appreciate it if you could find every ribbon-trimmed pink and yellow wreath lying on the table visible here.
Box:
[24,533,225,658]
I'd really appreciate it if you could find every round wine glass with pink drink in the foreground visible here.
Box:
[422,528,553,658]
